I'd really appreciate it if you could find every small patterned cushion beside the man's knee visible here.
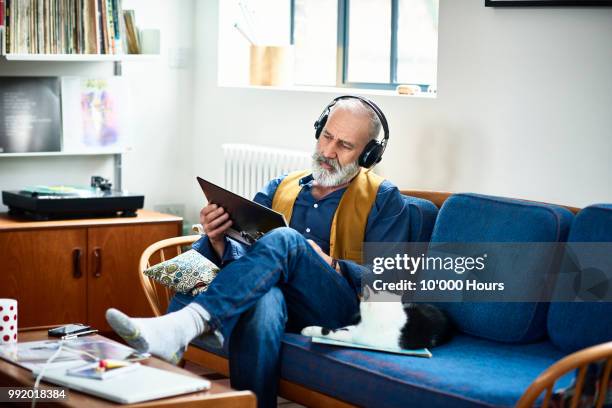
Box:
[144,249,219,296]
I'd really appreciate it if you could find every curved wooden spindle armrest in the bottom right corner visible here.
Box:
[516,341,612,408]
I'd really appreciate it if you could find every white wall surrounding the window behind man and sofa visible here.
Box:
[188,0,612,223]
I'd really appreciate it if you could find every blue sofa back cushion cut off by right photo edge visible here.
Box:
[548,204,612,352]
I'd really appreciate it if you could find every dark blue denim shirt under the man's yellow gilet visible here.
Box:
[193,175,410,293]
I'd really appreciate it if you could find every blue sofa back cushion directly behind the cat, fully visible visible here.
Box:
[431,194,573,343]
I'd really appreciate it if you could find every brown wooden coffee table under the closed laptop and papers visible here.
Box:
[0,328,257,408]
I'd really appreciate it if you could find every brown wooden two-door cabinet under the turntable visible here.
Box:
[0,211,182,331]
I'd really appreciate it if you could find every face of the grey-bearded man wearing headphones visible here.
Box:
[313,108,370,187]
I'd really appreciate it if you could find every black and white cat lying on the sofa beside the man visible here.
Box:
[302,287,452,350]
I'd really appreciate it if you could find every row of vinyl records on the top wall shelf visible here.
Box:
[0,0,138,54]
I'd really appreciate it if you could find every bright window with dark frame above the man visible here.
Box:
[219,0,439,91]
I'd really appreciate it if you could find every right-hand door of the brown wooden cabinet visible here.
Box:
[87,223,180,331]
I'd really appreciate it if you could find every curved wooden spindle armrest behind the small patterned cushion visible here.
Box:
[138,235,201,316]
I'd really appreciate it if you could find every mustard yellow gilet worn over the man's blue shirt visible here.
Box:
[272,169,384,263]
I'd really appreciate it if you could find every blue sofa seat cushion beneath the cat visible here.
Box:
[281,334,571,408]
